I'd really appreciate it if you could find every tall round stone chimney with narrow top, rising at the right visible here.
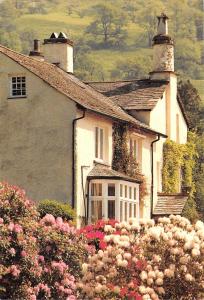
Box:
[150,13,174,79]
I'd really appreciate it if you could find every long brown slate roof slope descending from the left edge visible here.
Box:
[0,45,162,133]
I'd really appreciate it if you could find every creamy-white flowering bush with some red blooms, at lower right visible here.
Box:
[77,216,204,300]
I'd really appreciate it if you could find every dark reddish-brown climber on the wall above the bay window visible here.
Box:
[112,123,147,201]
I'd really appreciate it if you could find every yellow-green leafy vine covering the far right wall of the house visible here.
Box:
[162,132,198,221]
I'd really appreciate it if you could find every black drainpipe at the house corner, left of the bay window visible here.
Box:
[72,109,86,208]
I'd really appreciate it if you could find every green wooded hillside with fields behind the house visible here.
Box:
[0,0,204,88]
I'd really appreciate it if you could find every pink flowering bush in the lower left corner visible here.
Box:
[0,184,86,300]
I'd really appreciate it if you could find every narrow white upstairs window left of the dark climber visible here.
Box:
[94,126,105,161]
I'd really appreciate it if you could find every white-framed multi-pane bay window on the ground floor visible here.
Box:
[89,179,139,222]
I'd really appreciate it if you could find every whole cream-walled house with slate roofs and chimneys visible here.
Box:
[0,15,187,224]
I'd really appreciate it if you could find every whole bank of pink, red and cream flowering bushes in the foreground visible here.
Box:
[0,184,204,300]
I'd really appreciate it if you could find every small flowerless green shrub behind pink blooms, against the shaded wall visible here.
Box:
[38,199,76,221]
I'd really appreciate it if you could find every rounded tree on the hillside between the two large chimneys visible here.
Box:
[86,4,127,47]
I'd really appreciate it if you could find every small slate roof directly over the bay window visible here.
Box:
[88,163,142,183]
